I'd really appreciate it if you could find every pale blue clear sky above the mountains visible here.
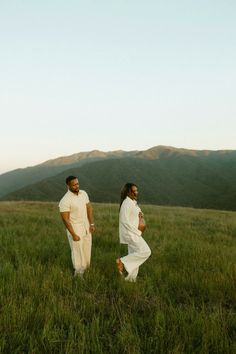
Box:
[0,0,236,173]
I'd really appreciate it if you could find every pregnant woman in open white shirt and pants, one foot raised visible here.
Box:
[116,183,151,282]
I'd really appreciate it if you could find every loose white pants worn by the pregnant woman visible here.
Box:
[120,236,151,281]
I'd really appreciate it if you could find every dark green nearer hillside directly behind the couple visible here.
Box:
[2,150,236,210]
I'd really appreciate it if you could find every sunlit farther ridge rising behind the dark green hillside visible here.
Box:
[0,146,229,197]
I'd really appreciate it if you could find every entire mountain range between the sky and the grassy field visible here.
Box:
[0,146,236,210]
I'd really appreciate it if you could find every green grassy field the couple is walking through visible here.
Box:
[0,202,236,354]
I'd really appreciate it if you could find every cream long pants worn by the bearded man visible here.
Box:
[67,225,92,274]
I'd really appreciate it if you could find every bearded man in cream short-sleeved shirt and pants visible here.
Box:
[59,176,95,277]
